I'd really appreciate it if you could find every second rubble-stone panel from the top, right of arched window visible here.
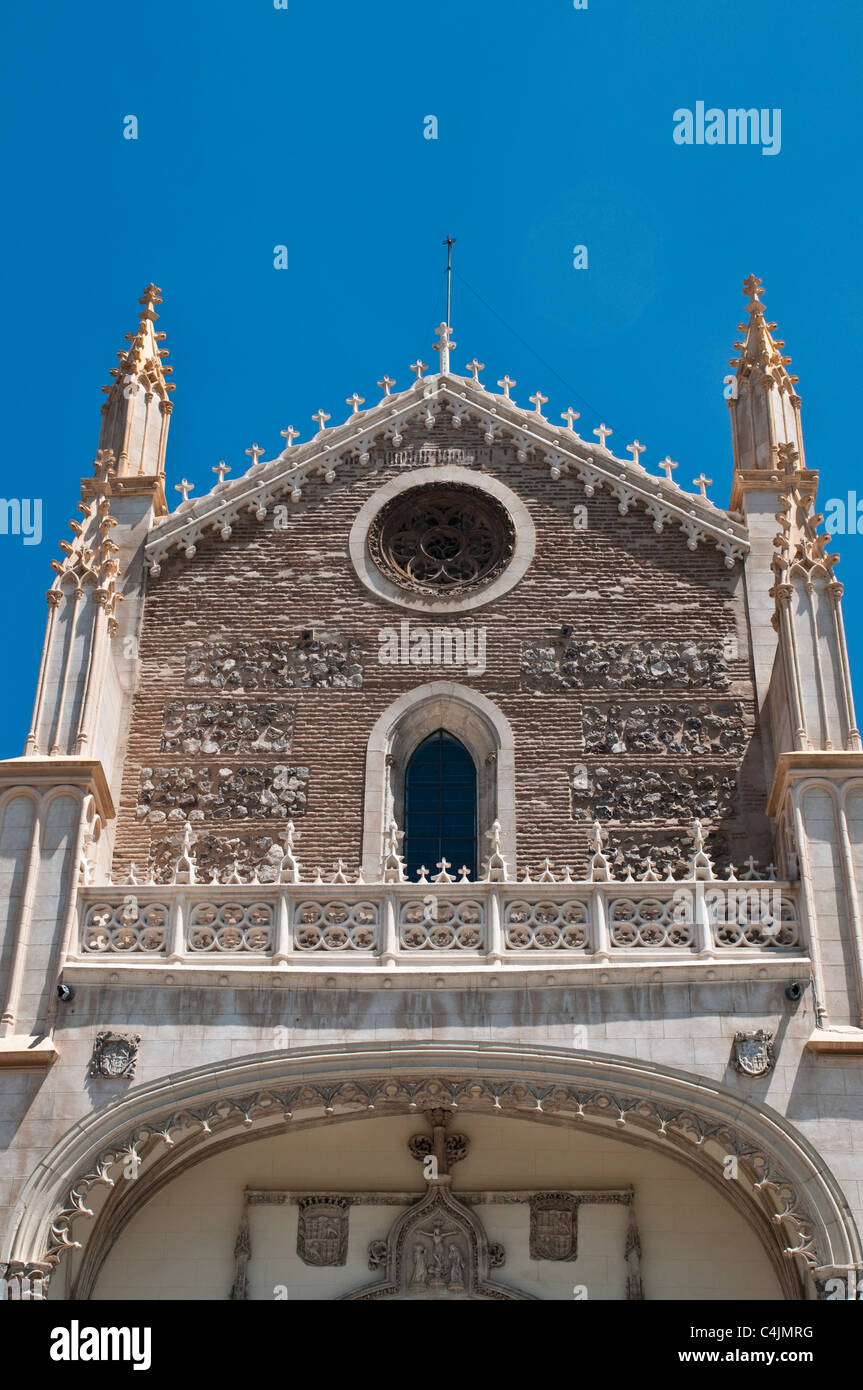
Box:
[582,702,748,758]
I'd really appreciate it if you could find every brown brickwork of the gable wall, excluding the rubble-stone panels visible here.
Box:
[114,425,773,874]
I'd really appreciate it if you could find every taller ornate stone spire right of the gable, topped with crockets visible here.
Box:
[727,275,805,480]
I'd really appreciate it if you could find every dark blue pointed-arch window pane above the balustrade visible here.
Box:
[403,728,477,883]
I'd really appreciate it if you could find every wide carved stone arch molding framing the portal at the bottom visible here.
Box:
[0,1043,863,1298]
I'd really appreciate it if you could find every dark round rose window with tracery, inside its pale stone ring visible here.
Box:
[368,484,516,596]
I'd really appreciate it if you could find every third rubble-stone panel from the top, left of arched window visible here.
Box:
[138,765,309,824]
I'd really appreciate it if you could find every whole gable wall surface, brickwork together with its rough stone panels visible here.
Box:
[114,425,773,874]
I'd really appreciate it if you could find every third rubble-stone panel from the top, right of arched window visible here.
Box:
[571,766,738,823]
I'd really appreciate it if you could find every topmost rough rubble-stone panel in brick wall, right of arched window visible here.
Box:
[521,639,731,692]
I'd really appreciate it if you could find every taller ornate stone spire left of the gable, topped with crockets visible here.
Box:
[99,284,174,516]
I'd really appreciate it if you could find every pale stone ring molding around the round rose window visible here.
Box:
[347,464,536,616]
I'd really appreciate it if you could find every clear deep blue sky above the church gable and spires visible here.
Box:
[0,0,863,756]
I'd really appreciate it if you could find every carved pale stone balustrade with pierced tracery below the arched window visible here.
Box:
[69,878,806,969]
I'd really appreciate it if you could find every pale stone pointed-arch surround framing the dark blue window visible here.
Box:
[363,681,516,881]
